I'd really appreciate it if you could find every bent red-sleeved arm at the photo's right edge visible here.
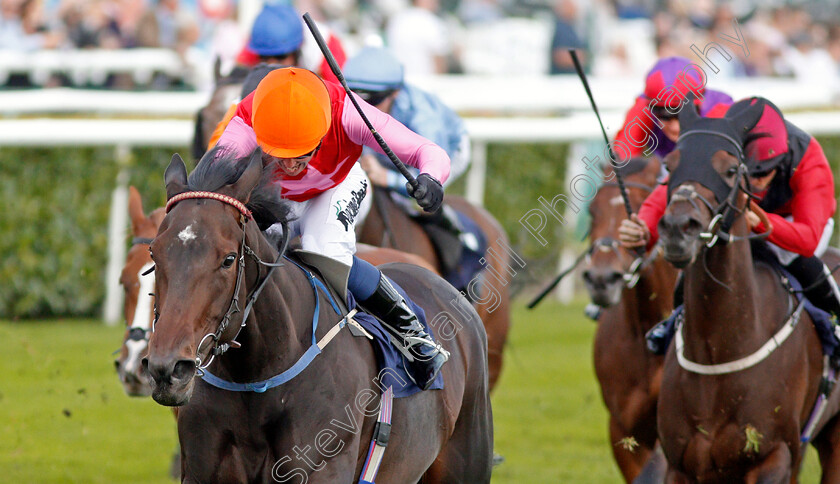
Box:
[754,138,837,257]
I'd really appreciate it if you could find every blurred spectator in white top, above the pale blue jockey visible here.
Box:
[386,0,452,77]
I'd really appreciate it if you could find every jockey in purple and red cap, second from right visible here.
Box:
[585,57,732,320]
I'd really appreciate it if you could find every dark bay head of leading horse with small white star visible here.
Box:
[143,150,286,405]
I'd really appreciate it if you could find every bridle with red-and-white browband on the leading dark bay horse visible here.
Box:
[157,191,289,376]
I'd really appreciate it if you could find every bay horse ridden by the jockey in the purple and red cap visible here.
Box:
[582,159,677,483]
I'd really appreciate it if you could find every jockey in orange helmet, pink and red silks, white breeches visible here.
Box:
[218,67,449,389]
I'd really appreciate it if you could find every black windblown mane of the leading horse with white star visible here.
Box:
[187,147,291,230]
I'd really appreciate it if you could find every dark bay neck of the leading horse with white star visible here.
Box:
[215,235,313,382]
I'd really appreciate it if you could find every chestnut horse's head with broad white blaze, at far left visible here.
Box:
[114,187,164,397]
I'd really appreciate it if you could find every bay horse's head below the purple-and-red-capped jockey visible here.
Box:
[583,158,660,307]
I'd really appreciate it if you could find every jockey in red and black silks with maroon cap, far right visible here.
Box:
[620,97,840,353]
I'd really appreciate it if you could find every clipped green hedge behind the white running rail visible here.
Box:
[0,138,840,319]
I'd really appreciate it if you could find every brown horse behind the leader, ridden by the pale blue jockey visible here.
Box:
[357,188,512,390]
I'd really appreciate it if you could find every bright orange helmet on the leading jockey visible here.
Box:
[251,67,332,158]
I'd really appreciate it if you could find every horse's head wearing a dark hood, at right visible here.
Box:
[658,99,761,268]
